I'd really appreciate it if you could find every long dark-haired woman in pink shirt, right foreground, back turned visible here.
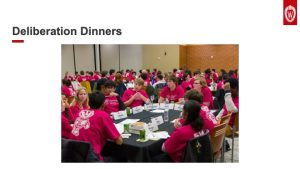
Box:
[152,100,204,162]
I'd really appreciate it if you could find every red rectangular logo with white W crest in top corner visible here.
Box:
[283,0,297,25]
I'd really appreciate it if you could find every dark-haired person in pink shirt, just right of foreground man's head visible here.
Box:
[104,80,125,114]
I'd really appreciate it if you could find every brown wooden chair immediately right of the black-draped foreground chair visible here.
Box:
[211,123,227,161]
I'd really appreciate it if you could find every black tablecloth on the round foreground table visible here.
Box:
[101,110,180,162]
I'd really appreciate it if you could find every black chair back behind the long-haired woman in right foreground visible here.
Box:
[182,130,213,162]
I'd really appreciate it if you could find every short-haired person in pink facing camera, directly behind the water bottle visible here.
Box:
[158,75,184,104]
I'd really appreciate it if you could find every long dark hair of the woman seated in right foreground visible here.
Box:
[183,100,203,132]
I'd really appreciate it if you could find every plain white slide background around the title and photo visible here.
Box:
[0,0,300,169]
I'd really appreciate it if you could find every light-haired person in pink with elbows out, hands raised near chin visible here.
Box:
[122,78,149,108]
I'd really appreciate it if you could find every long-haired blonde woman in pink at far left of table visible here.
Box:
[70,87,90,118]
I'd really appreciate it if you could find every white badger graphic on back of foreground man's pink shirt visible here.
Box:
[72,110,94,136]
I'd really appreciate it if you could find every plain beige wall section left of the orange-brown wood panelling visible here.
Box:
[143,45,179,72]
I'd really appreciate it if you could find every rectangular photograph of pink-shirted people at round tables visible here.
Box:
[61,44,239,163]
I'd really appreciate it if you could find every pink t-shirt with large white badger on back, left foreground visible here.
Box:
[70,110,120,160]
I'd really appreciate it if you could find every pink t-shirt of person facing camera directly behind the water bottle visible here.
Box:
[160,86,184,102]
